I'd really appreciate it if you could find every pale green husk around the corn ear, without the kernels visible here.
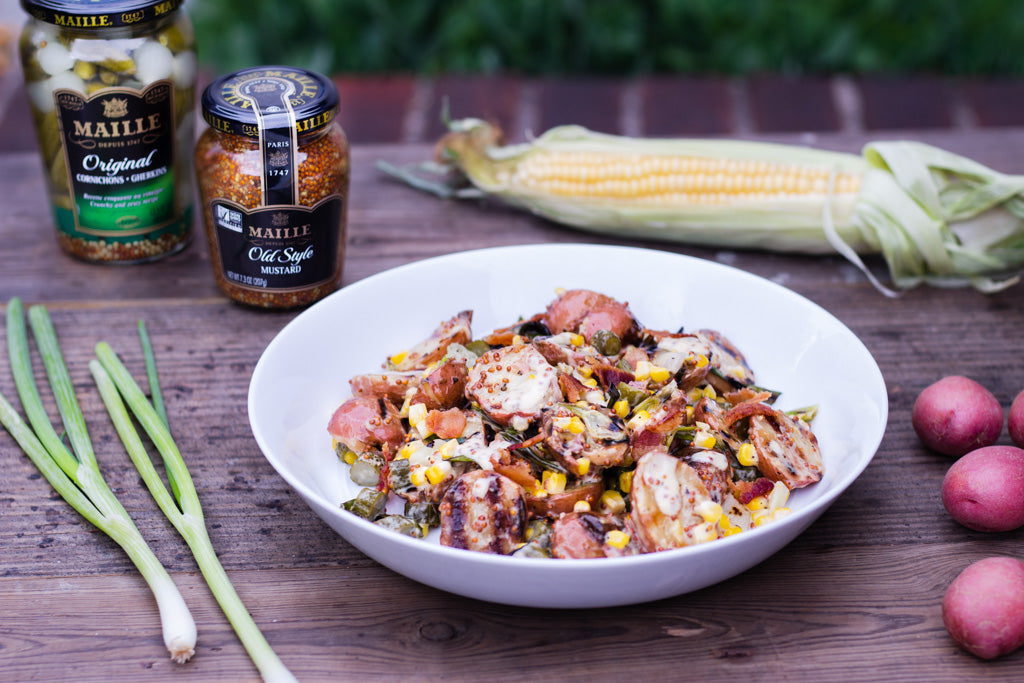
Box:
[379,119,1024,296]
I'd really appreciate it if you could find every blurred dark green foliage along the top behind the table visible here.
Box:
[186,0,1024,76]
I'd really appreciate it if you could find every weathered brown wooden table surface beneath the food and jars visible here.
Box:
[0,129,1024,682]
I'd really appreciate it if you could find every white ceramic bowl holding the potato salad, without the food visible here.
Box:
[249,245,888,607]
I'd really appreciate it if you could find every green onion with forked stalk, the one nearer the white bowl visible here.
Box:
[89,342,295,681]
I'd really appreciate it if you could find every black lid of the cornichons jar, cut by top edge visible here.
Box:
[22,0,184,31]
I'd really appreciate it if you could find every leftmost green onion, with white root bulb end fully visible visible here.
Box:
[0,298,196,664]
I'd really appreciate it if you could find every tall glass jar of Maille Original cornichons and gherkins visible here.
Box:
[19,0,197,263]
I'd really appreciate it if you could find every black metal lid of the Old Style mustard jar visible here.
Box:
[202,67,338,137]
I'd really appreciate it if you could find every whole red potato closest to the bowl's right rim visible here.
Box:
[912,375,1002,458]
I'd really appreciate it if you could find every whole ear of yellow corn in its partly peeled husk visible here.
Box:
[380,119,1024,294]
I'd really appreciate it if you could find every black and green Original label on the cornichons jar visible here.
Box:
[54,81,176,238]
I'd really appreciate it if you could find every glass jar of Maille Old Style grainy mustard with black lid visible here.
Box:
[195,67,349,308]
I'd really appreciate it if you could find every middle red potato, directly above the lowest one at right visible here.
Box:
[942,445,1024,531]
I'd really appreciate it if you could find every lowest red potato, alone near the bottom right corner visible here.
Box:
[942,557,1024,659]
